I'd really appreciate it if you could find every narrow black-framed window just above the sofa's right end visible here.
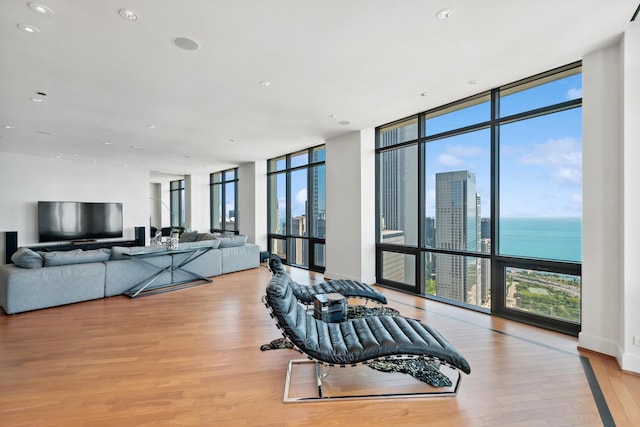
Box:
[209,168,239,234]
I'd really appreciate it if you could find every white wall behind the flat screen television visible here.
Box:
[0,153,150,263]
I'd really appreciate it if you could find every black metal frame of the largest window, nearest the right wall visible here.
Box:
[375,62,582,336]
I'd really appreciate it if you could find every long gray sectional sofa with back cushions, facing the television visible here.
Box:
[0,233,260,314]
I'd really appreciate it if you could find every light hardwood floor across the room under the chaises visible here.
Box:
[0,267,640,427]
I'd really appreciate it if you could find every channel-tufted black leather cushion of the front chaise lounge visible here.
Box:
[266,272,471,374]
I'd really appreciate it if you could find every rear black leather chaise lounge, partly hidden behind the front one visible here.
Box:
[269,254,387,305]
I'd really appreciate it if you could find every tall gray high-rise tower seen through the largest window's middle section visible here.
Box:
[435,170,480,304]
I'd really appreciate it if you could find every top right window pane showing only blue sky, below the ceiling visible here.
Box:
[500,68,582,117]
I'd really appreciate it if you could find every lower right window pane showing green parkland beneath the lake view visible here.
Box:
[505,267,581,323]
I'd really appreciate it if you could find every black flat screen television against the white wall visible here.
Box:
[38,202,122,242]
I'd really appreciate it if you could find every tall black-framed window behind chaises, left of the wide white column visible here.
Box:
[268,146,326,271]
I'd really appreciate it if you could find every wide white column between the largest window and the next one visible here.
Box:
[324,129,376,283]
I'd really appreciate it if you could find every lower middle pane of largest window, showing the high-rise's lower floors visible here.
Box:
[424,253,491,308]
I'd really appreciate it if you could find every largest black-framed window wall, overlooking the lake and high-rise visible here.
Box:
[376,64,582,334]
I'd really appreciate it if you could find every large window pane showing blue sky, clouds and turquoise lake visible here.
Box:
[499,108,582,261]
